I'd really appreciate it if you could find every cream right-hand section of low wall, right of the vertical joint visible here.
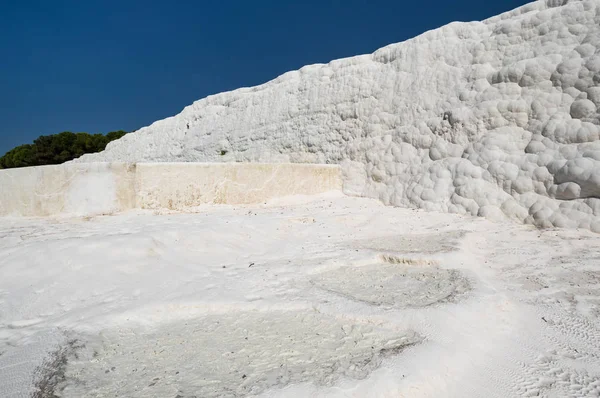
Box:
[135,163,342,210]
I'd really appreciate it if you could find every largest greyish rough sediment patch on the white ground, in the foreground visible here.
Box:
[61,311,421,397]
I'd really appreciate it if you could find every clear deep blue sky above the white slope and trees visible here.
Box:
[0,0,528,155]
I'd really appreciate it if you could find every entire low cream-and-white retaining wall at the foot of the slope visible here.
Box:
[0,163,342,216]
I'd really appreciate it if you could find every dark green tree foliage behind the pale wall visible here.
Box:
[0,130,127,169]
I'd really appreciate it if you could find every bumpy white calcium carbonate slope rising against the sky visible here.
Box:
[78,0,600,232]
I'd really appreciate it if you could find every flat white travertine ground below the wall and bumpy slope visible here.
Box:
[0,194,600,398]
